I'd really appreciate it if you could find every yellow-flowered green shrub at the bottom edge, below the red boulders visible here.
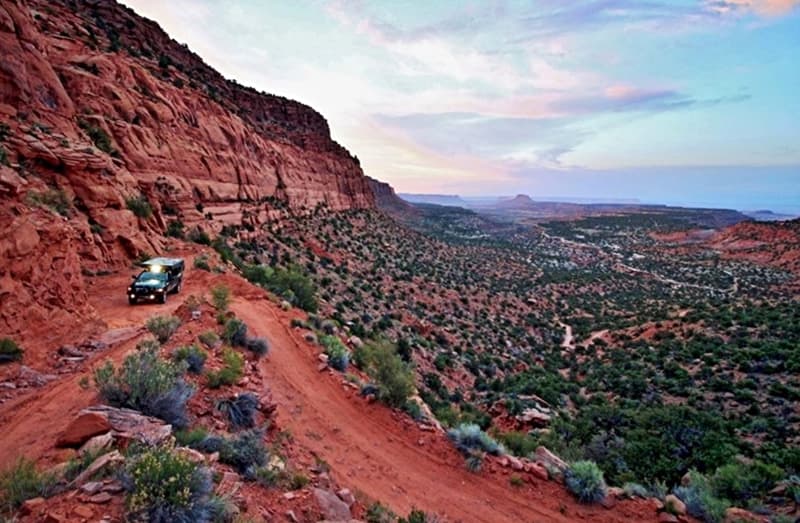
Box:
[121,446,215,523]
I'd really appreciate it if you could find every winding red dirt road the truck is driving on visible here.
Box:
[0,263,657,523]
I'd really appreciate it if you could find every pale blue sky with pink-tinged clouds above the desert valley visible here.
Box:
[123,0,800,213]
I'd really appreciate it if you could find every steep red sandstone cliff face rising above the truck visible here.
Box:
[0,0,374,348]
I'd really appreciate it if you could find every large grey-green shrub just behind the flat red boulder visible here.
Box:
[94,342,194,429]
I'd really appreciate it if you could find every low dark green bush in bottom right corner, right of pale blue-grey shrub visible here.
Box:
[711,460,784,503]
